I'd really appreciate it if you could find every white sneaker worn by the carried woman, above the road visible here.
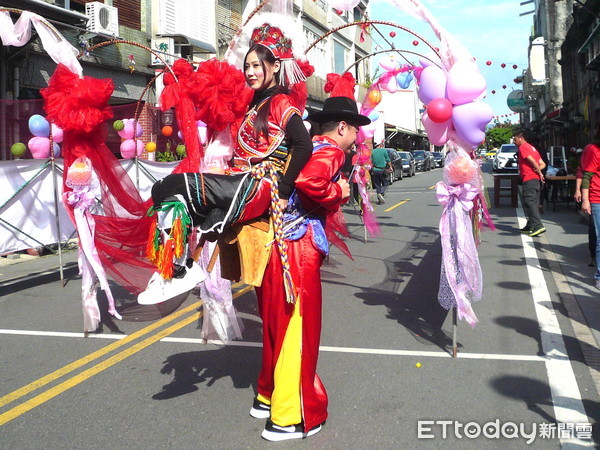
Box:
[138,263,206,305]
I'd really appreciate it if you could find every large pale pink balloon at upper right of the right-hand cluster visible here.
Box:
[446,59,486,105]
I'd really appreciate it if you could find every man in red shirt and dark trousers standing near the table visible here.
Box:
[514,131,546,237]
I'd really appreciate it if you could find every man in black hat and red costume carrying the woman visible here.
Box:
[250,93,370,441]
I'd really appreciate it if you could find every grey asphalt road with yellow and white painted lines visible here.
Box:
[0,160,600,449]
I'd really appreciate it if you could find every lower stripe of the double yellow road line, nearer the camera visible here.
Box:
[0,313,202,426]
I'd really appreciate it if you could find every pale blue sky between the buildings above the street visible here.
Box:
[370,0,534,123]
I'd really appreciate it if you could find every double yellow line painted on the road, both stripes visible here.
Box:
[0,286,253,426]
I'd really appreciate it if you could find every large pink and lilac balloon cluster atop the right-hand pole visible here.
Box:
[418,59,493,147]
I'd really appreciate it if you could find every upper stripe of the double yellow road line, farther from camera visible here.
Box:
[0,302,202,407]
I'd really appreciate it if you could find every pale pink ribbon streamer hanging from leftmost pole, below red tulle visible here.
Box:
[63,186,121,331]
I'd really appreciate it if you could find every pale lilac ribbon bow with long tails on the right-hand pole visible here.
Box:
[436,181,483,327]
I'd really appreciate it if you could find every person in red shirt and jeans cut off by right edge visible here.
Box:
[581,123,600,289]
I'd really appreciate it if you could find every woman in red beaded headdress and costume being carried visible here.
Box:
[138,23,312,304]
